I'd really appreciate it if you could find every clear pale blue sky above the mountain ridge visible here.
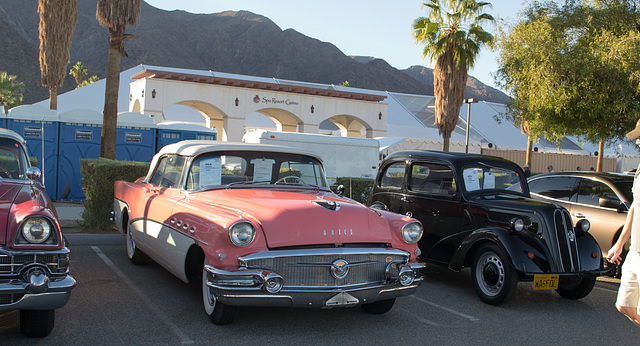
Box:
[145,0,525,92]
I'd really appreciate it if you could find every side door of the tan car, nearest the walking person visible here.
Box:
[569,178,627,252]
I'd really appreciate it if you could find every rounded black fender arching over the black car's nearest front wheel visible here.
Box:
[449,227,549,273]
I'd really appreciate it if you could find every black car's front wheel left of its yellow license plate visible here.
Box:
[471,244,518,305]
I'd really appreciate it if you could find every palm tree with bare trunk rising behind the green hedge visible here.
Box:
[96,0,142,159]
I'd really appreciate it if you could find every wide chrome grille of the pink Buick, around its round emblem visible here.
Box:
[245,251,409,287]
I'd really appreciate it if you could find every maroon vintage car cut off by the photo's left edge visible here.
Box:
[0,129,76,337]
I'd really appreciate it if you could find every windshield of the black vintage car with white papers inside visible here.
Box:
[462,164,524,193]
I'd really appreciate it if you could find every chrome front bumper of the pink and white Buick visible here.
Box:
[205,256,424,309]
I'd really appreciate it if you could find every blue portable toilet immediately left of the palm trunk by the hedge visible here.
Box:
[56,109,102,201]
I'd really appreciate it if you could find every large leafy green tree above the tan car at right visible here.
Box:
[496,0,640,170]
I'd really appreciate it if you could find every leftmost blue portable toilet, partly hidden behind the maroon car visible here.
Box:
[6,105,59,198]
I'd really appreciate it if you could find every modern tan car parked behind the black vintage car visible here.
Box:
[529,172,633,268]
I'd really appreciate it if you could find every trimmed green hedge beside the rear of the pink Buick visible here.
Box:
[80,158,149,230]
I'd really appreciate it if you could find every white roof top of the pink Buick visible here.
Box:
[145,140,322,181]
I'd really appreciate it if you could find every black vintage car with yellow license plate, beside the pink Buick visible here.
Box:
[369,151,606,305]
